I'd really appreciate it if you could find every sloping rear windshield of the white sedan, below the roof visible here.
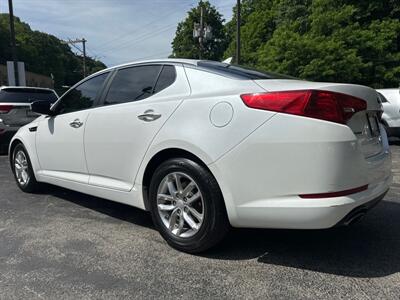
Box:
[197,60,297,80]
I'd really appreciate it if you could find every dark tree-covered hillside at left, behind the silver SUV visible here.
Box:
[0,14,106,88]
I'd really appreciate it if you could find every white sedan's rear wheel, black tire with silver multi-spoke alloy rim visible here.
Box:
[149,158,230,253]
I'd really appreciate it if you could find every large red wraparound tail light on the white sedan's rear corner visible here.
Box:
[241,90,367,124]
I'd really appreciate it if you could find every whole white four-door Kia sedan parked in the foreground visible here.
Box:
[9,59,391,253]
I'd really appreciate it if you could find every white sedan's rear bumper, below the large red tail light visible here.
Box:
[209,115,392,229]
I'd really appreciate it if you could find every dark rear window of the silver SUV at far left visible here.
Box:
[0,88,58,103]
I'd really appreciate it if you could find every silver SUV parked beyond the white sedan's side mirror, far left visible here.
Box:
[0,86,58,152]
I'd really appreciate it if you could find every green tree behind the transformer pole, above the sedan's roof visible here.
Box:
[171,1,226,60]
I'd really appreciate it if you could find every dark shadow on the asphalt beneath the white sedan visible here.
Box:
[43,183,400,277]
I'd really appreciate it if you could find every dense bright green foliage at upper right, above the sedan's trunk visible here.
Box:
[225,0,400,87]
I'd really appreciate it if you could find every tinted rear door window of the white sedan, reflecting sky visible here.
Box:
[104,65,161,105]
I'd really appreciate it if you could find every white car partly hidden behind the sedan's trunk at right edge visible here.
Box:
[377,88,400,137]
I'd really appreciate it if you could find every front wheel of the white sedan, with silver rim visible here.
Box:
[11,143,40,193]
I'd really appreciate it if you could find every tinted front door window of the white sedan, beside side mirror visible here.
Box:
[56,73,108,114]
